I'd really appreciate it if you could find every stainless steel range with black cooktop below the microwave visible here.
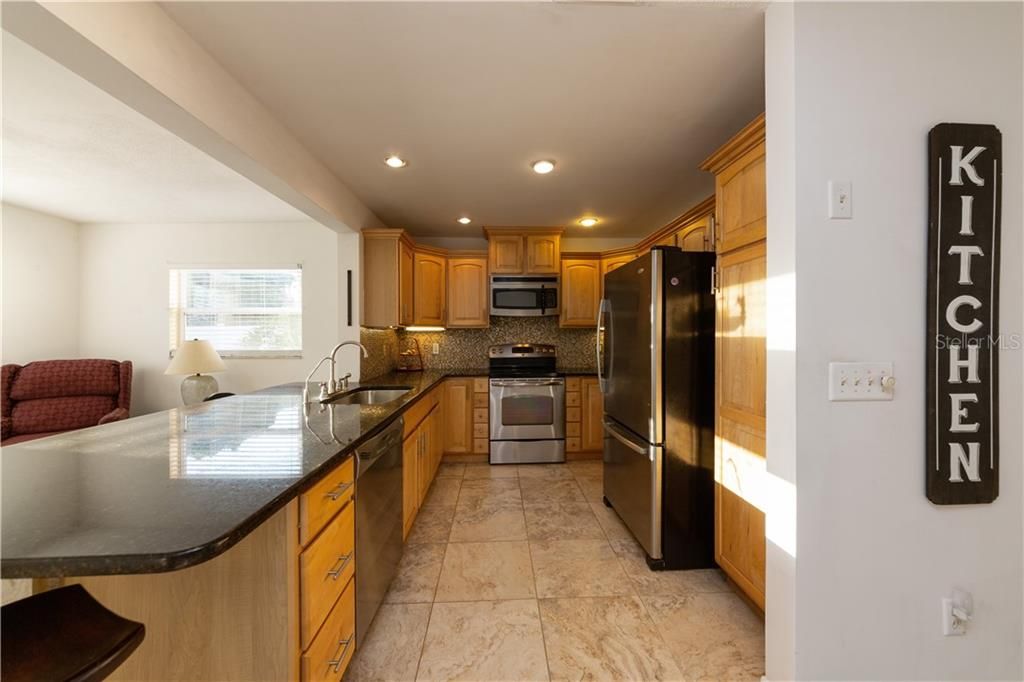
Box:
[487,343,565,464]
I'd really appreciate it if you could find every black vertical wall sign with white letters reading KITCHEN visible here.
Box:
[926,123,1002,505]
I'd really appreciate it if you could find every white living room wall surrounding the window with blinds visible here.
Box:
[79,222,358,415]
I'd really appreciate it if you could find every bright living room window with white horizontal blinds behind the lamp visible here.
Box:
[170,267,302,357]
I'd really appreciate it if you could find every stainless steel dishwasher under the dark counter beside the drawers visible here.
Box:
[355,417,406,646]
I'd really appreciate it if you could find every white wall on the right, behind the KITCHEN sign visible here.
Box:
[766,3,1024,680]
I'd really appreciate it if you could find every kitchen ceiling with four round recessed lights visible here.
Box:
[163,2,764,238]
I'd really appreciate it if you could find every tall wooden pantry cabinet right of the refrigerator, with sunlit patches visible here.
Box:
[701,115,767,609]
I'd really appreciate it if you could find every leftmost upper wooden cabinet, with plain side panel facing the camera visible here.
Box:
[362,229,415,327]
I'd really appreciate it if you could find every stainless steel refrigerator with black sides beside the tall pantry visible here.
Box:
[597,247,715,569]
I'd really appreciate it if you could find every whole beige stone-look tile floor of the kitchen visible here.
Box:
[346,462,764,682]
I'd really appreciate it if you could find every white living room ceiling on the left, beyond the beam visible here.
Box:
[2,32,309,223]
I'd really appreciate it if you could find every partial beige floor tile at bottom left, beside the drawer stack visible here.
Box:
[345,604,430,682]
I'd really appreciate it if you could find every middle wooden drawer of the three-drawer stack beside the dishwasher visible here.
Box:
[299,504,355,649]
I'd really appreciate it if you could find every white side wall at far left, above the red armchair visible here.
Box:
[0,204,79,365]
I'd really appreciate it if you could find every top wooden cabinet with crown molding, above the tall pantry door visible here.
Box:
[700,114,768,253]
